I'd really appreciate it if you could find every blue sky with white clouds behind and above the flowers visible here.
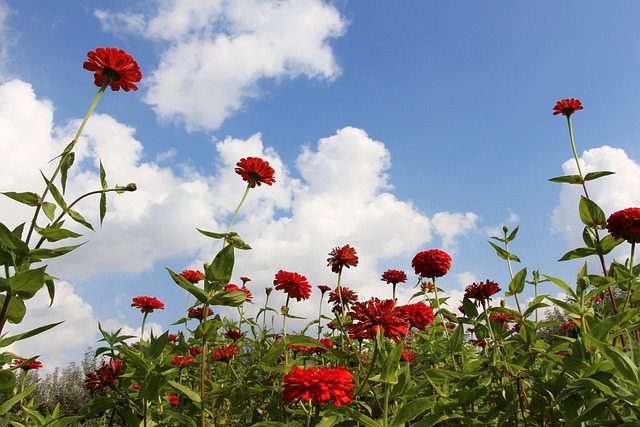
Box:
[0,0,640,372]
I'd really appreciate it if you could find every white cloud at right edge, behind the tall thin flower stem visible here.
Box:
[551,145,640,261]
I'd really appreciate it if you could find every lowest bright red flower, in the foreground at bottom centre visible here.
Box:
[282,366,356,407]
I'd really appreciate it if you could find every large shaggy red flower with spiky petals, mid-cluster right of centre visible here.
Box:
[346,298,409,339]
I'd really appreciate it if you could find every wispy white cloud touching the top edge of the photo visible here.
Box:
[96,0,346,130]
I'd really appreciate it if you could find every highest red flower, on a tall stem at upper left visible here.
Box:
[82,47,142,92]
